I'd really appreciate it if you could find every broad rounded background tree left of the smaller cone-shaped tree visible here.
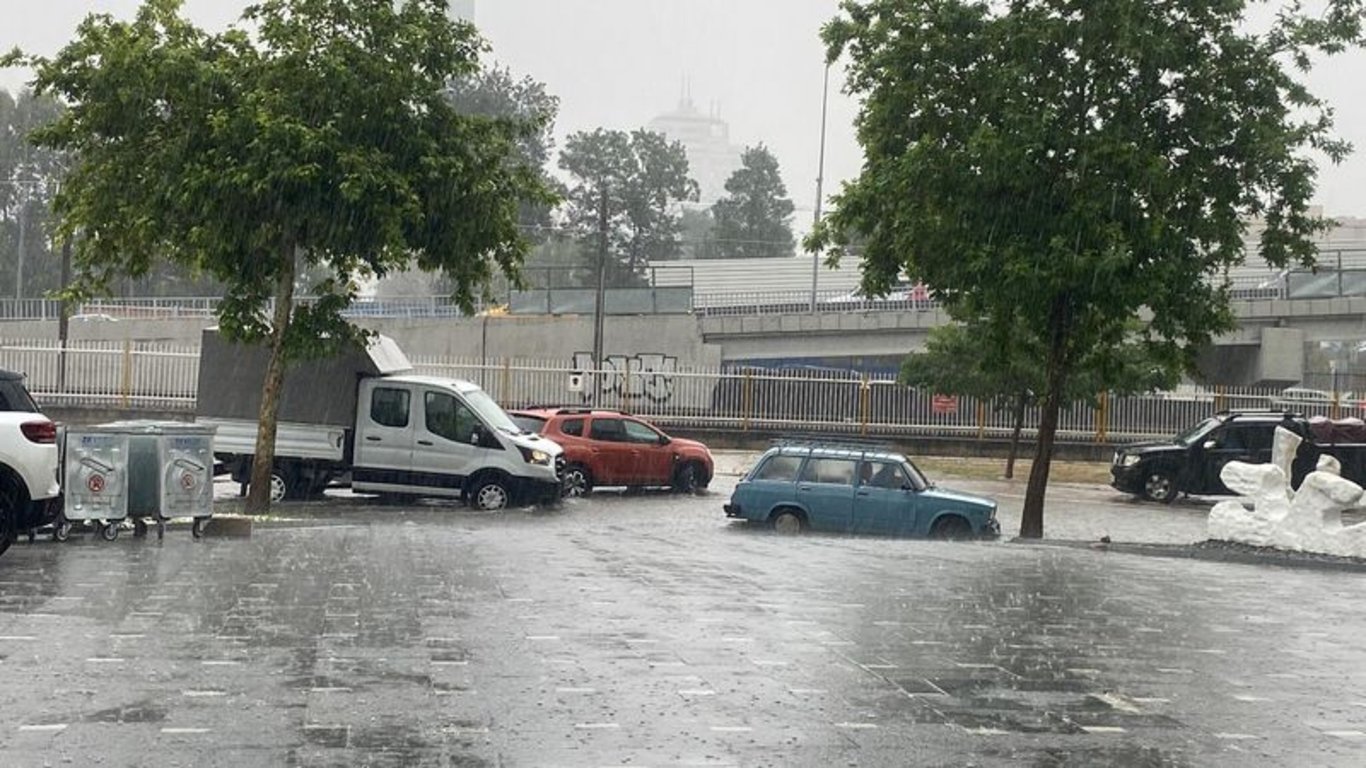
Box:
[560,128,698,284]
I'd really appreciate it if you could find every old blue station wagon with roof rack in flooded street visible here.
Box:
[725,445,1001,538]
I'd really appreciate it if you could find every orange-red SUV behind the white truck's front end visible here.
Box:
[510,407,713,496]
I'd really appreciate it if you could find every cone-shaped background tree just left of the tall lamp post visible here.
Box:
[712,143,795,258]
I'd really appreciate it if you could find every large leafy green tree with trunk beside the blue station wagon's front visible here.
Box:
[810,0,1362,537]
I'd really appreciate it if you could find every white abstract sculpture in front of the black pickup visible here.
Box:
[1209,426,1366,558]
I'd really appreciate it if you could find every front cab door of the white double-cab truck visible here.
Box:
[413,388,482,492]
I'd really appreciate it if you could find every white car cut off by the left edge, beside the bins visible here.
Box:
[0,370,61,552]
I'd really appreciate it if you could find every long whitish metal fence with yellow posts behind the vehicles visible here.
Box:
[0,340,1362,443]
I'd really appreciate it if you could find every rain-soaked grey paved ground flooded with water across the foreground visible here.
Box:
[0,467,1366,767]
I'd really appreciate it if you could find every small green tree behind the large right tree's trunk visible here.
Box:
[900,316,1179,478]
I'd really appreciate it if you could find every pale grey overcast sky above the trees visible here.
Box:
[0,0,1366,221]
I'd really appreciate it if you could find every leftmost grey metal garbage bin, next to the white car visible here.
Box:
[62,425,128,541]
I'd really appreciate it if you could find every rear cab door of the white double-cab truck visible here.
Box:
[352,383,414,485]
